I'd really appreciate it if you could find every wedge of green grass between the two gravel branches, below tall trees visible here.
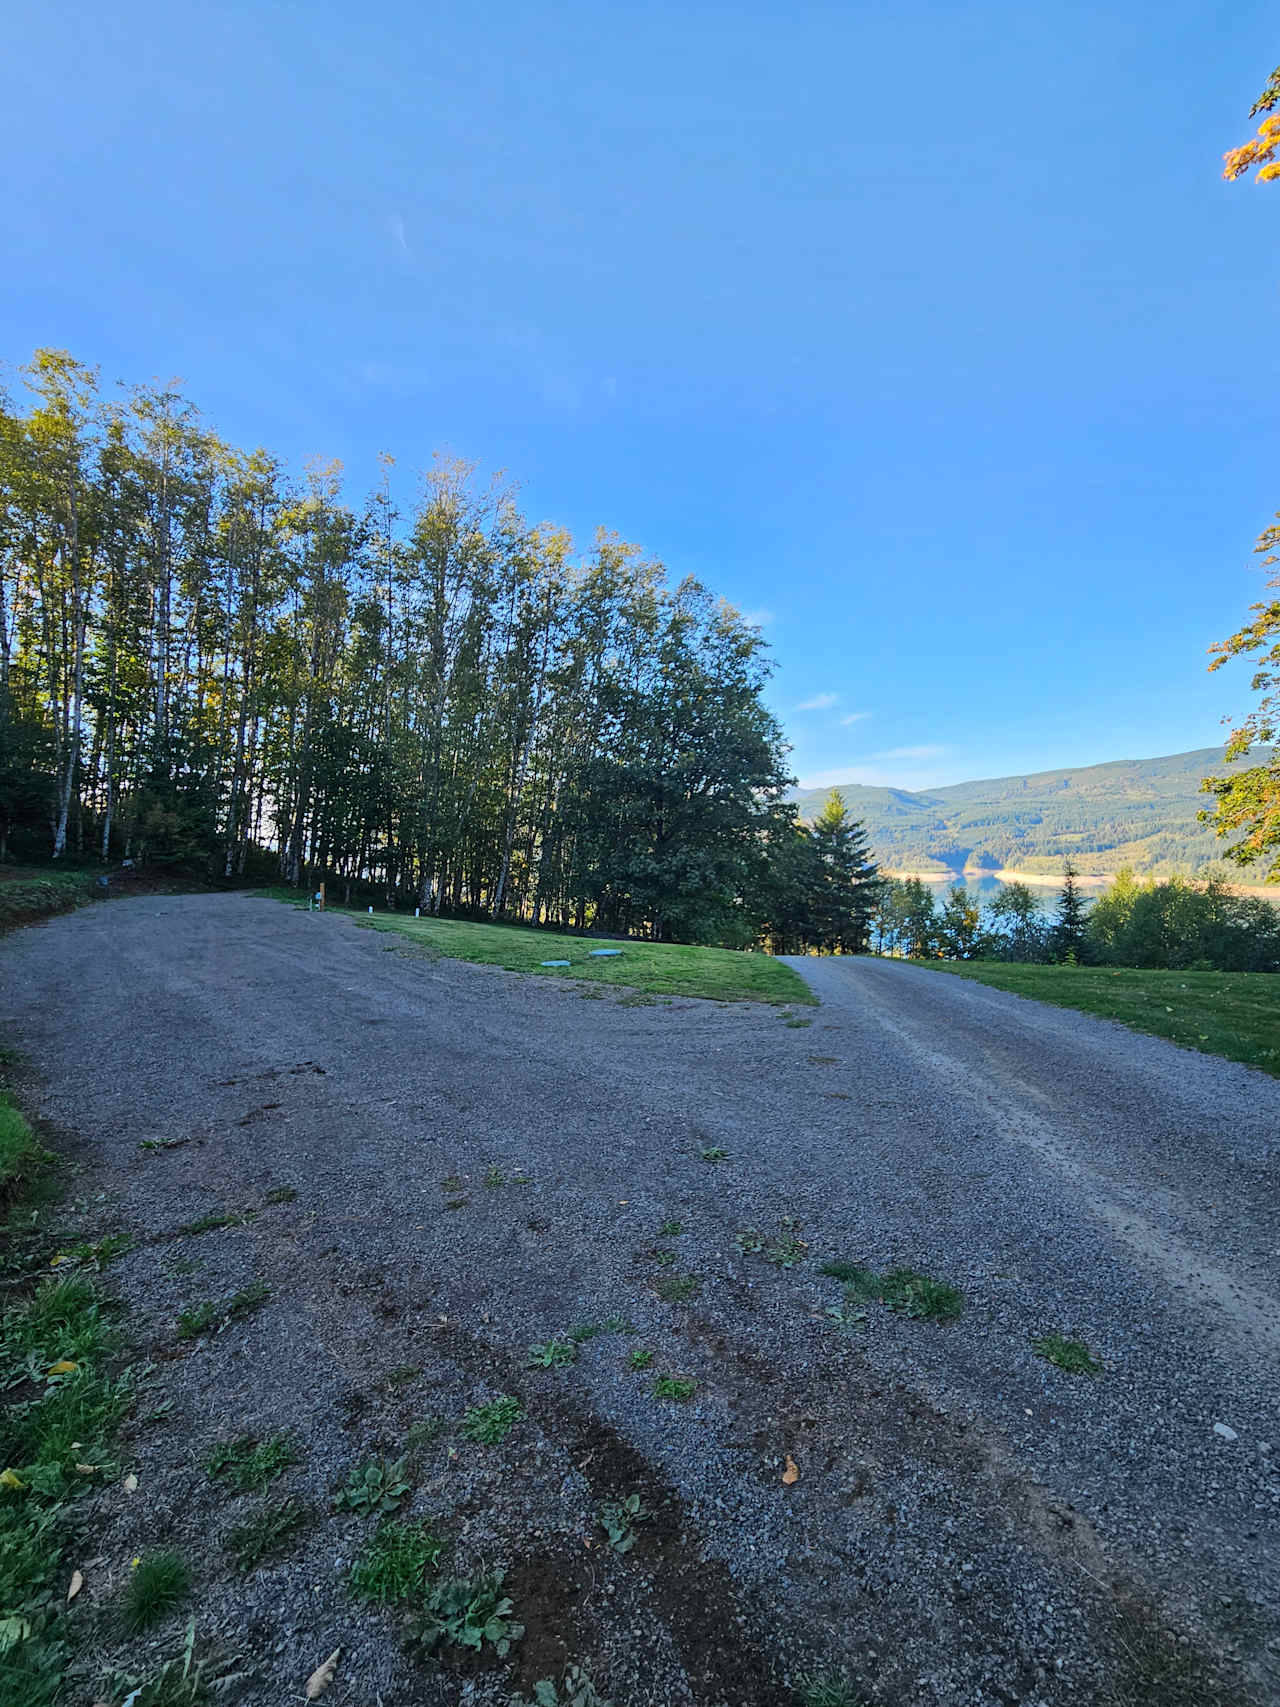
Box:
[270,889,816,1004]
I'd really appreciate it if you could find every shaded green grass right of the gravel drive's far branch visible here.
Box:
[916,961,1280,1077]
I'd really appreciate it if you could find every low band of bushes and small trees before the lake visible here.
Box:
[872,867,1280,971]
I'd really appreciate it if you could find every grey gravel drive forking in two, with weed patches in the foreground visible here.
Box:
[0,896,1280,1707]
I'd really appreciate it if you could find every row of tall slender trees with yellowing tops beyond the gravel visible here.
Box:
[0,350,872,947]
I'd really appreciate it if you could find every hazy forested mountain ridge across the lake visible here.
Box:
[792,748,1258,881]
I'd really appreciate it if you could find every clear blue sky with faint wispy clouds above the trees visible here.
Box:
[0,0,1280,787]
